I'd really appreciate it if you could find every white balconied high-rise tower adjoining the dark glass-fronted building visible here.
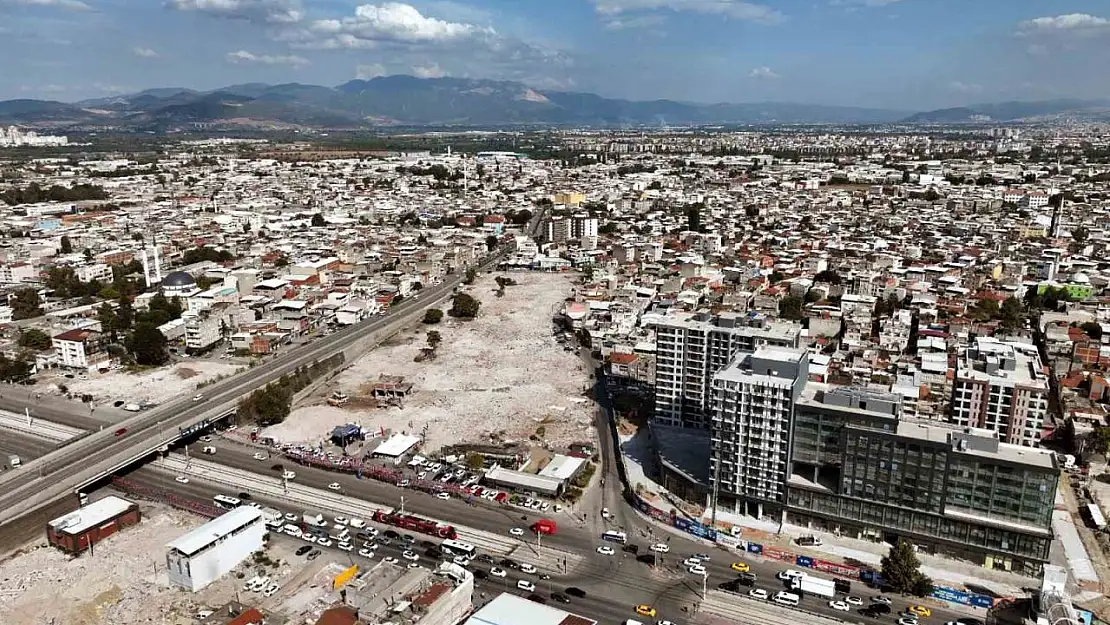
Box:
[709,346,809,517]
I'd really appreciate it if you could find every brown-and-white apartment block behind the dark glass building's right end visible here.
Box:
[951,336,1049,447]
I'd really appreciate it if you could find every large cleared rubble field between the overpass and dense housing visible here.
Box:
[265,272,595,451]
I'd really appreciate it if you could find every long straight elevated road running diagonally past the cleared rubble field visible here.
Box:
[0,211,545,535]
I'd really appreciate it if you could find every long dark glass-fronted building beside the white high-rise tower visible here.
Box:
[786,383,1059,575]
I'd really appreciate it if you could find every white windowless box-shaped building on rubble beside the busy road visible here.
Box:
[165,506,266,593]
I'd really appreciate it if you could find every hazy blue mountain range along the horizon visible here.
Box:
[0,75,1110,130]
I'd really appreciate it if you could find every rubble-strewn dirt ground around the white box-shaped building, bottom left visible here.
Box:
[0,502,302,625]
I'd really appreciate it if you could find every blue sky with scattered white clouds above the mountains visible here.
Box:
[0,0,1110,110]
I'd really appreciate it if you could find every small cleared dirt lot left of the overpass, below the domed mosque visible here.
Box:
[36,361,243,404]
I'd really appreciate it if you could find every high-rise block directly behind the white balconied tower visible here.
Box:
[654,313,801,429]
